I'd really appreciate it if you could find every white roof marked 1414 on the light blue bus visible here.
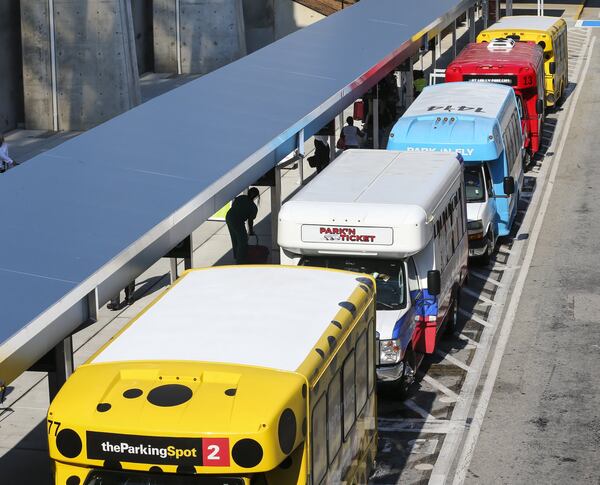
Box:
[402,82,512,118]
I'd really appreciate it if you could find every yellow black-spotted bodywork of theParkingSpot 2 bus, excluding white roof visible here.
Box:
[46,269,377,485]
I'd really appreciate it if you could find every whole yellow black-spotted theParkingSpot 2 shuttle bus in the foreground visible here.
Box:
[47,266,377,485]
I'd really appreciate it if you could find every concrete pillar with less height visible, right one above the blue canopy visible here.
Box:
[153,0,246,74]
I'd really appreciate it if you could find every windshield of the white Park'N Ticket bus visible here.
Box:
[300,256,406,310]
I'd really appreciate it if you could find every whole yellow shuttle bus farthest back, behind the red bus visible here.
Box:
[477,15,569,106]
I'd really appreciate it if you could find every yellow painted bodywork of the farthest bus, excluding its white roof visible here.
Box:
[477,17,569,106]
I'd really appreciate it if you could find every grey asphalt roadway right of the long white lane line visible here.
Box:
[465,27,600,484]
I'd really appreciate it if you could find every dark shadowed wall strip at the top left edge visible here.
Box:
[0,1,24,133]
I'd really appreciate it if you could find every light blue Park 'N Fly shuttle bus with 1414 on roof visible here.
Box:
[387,82,525,262]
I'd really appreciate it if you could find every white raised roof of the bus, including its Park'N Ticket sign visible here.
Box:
[278,150,462,257]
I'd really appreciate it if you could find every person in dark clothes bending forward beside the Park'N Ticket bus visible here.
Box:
[225,187,260,264]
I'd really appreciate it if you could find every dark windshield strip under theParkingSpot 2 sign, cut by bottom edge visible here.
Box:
[85,470,244,485]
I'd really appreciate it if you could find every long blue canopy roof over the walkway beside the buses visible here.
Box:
[0,0,474,382]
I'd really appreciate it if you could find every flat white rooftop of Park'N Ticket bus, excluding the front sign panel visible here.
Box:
[280,150,461,220]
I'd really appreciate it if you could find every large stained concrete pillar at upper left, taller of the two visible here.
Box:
[21,0,141,130]
